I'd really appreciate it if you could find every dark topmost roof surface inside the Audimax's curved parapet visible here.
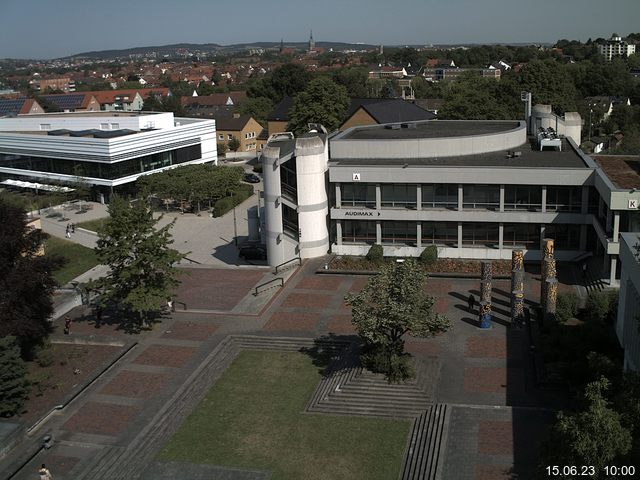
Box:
[334,120,520,140]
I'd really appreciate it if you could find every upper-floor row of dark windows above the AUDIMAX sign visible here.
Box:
[340,183,597,212]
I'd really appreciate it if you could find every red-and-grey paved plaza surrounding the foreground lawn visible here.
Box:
[3,259,576,480]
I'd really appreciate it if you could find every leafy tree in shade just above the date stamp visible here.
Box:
[543,377,632,478]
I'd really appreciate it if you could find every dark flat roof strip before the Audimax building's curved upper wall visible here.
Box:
[329,139,590,168]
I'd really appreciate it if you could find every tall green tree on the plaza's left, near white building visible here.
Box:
[85,195,185,326]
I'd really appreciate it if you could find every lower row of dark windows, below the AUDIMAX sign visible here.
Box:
[342,220,580,250]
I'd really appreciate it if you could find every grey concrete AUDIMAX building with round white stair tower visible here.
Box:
[263,106,640,285]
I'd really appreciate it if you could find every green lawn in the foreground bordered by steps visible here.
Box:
[160,350,410,480]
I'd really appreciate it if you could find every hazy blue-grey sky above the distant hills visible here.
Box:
[0,0,640,58]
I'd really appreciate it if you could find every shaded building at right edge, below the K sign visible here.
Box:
[616,233,640,372]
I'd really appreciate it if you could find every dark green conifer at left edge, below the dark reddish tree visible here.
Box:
[0,337,29,417]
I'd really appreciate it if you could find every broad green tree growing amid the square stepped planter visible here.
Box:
[345,260,451,381]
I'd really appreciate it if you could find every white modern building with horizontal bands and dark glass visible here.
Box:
[0,112,217,197]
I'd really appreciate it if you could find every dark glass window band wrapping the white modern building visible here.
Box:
[0,145,202,180]
